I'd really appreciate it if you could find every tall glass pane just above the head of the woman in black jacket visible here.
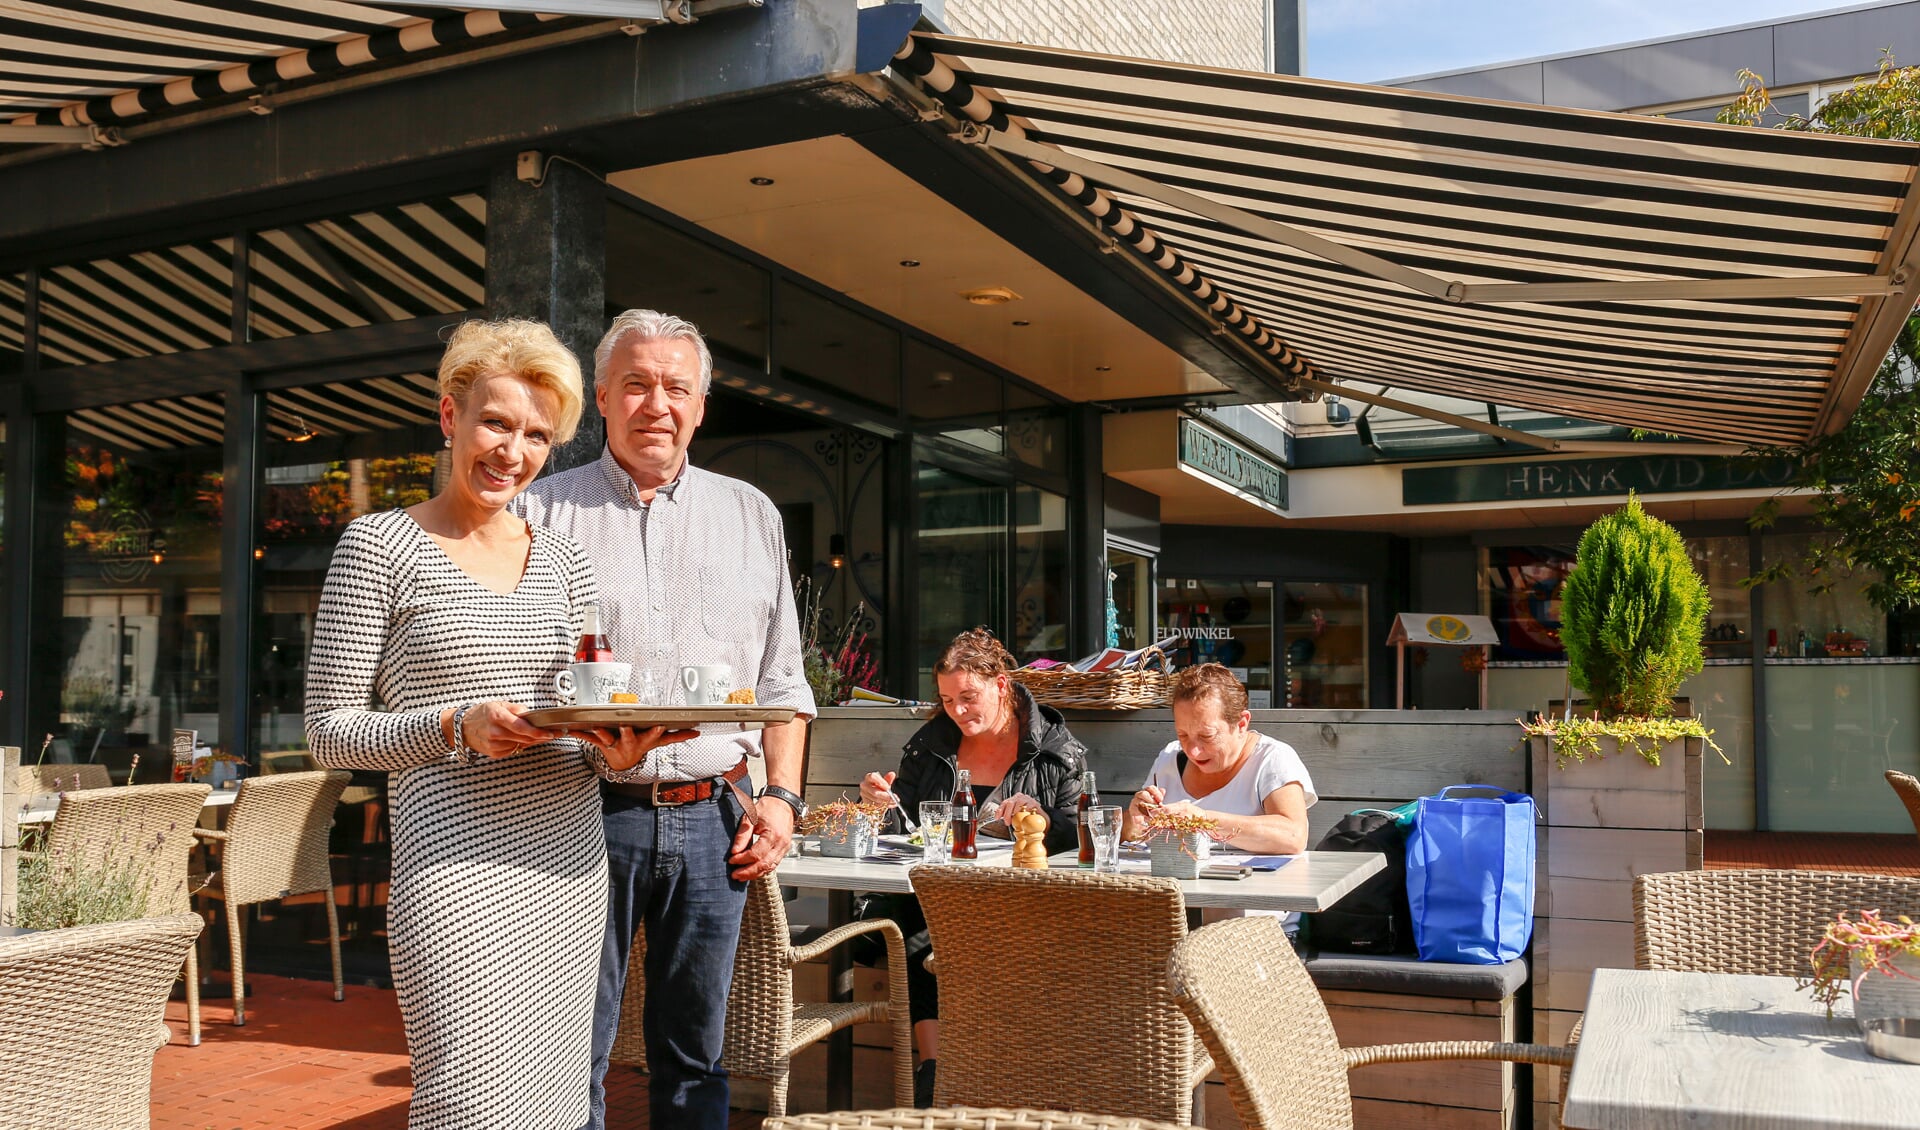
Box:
[914,464,1025,698]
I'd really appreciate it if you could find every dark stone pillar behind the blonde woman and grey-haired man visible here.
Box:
[486,153,607,474]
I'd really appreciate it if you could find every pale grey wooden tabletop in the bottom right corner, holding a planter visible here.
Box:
[1561,969,1920,1130]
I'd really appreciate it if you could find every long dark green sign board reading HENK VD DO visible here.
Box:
[1400,455,1793,506]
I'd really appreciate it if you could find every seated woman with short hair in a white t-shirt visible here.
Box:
[1123,664,1319,856]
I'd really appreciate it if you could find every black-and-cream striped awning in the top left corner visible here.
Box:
[0,0,559,130]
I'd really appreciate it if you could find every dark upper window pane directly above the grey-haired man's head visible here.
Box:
[607,203,768,370]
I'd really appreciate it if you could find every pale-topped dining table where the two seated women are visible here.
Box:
[778,842,1386,1111]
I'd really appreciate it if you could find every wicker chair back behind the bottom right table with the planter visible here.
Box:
[1634,869,1920,977]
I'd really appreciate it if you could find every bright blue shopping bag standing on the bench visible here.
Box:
[1407,785,1534,965]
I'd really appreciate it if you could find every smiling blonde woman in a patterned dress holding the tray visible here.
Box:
[307,320,678,1130]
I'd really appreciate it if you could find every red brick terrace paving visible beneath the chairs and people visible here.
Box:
[154,833,1920,1130]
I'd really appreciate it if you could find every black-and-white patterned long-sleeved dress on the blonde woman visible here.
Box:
[307,510,607,1130]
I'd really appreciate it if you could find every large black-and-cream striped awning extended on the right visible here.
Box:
[893,35,1920,445]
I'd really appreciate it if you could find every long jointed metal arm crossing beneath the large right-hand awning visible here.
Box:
[960,125,1907,305]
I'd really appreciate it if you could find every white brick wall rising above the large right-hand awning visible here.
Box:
[860,0,1269,71]
